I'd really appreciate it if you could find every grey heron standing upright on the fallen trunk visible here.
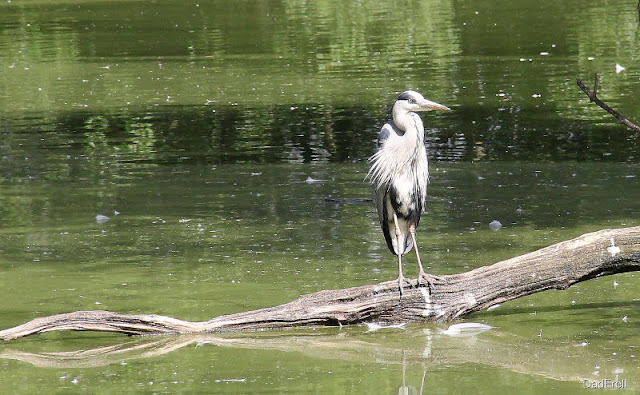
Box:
[367,91,449,295]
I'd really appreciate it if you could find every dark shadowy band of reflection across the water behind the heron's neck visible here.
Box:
[0,104,638,168]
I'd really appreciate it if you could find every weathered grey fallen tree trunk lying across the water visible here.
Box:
[0,226,640,340]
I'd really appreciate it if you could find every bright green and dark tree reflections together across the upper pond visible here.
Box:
[0,0,640,163]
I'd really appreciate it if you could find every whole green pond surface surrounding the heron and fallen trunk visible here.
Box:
[0,0,640,394]
